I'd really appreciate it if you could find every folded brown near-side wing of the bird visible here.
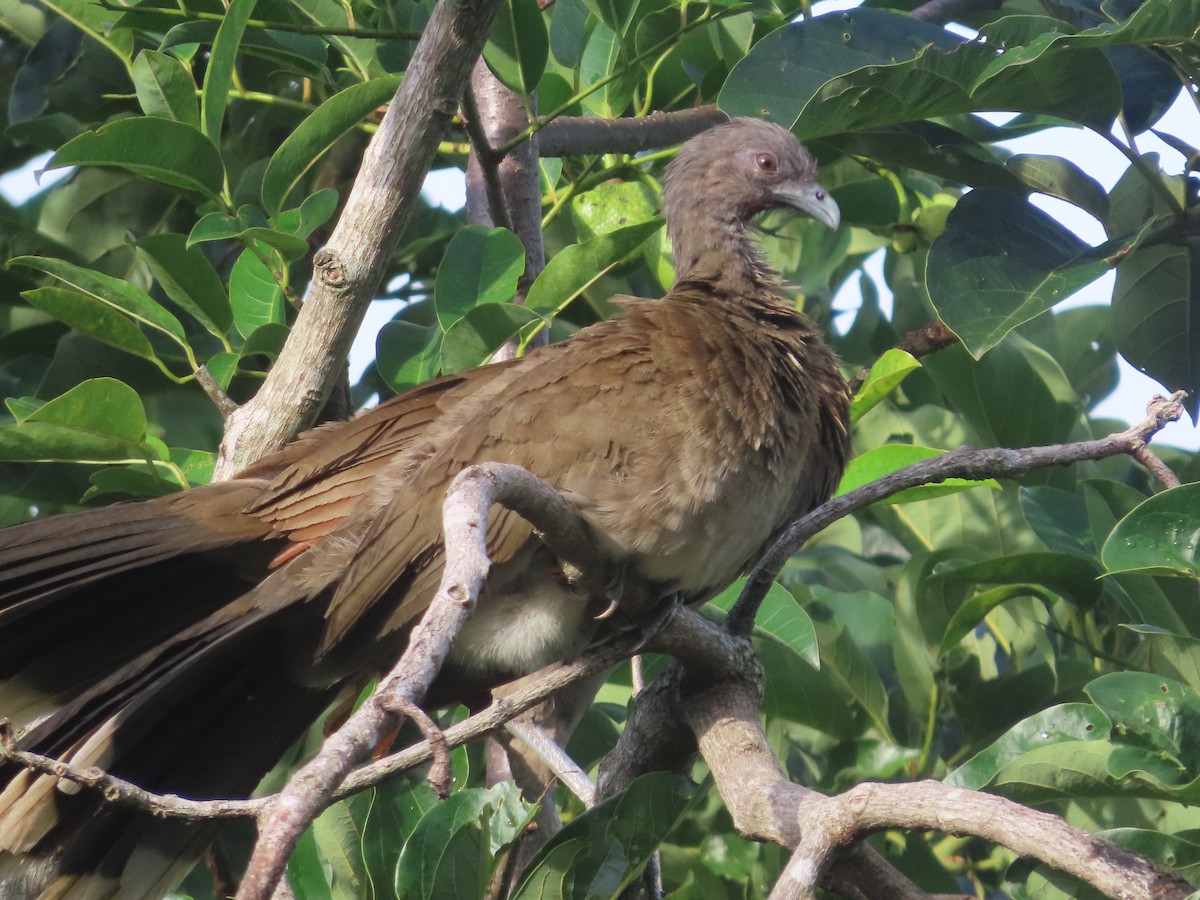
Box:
[312,320,670,649]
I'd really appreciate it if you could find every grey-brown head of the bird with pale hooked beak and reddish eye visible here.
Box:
[662,119,841,283]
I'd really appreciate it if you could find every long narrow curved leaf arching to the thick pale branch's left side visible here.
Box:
[263,76,400,215]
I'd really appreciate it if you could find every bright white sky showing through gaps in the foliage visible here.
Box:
[0,15,1200,449]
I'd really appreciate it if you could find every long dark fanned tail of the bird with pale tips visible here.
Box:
[0,481,330,899]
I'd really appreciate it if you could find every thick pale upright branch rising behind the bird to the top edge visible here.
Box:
[216,0,499,478]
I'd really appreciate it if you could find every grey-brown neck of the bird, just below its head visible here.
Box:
[670,216,781,292]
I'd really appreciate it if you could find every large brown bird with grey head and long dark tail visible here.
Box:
[0,119,850,900]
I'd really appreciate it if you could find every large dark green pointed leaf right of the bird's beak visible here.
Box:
[925,188,1109,359]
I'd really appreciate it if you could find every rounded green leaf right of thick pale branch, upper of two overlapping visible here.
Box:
[433,226,524,331]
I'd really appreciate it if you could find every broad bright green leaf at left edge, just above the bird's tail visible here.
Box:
[0,378,152,462]
